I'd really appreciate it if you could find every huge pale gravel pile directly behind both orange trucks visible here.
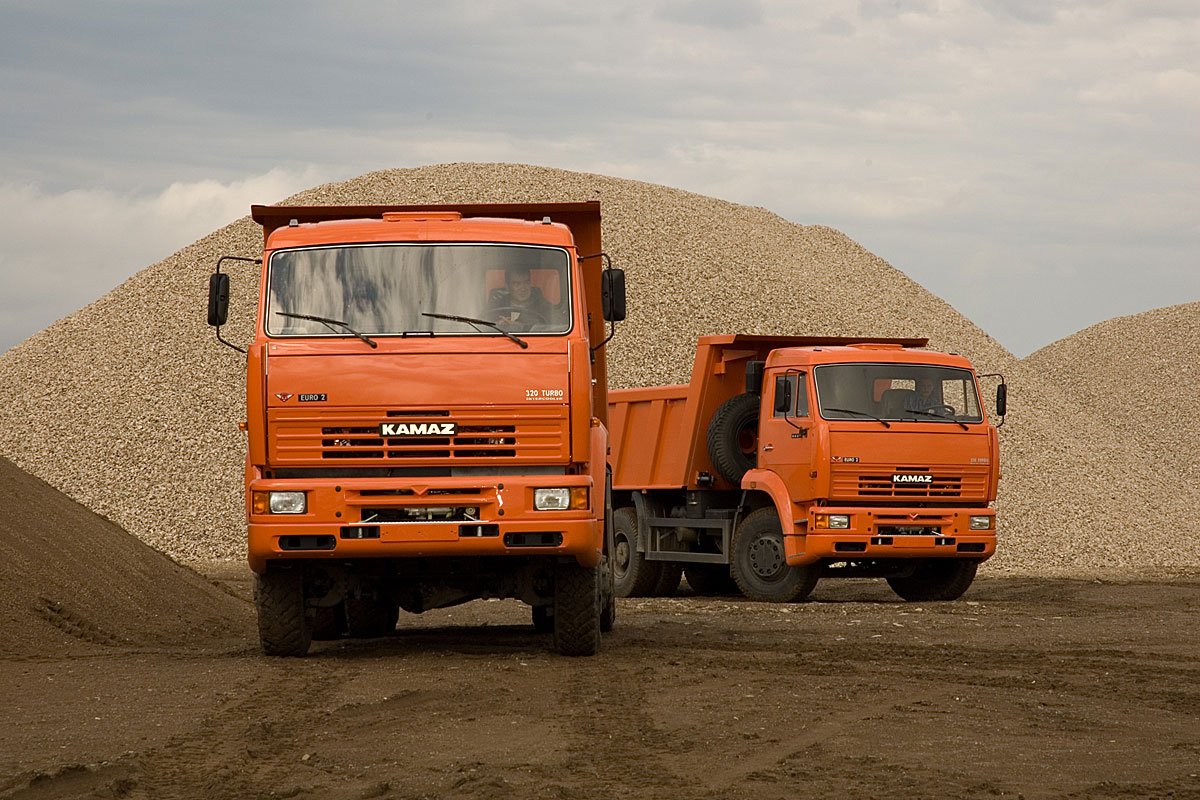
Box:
[0,164,1200,573]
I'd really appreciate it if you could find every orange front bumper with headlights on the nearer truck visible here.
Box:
[246,475,604,572]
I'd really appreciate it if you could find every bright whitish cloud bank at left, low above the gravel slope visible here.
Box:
[0,169,325,351]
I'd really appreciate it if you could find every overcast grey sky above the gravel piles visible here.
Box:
[0,0,1200,355]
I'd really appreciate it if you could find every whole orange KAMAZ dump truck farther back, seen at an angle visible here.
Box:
[608,335,1007,602]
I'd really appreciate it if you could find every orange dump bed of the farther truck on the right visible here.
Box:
[608,333,925,489]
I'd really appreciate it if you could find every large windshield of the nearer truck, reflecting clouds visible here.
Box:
[266,243,571,336]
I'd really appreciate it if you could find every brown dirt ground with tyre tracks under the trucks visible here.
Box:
[0,565,1200,800]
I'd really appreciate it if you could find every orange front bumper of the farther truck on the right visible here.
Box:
[784,506,996,566]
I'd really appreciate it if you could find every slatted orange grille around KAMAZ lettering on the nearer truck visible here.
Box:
[268,407,568,465]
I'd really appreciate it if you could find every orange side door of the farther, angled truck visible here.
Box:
[758,368,812,500]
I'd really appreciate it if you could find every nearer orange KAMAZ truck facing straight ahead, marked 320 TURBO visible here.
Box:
[209,201,625,656]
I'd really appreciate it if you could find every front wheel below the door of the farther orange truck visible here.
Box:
[731,507,821,603]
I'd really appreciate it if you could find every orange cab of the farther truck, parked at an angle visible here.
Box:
[742,343,1000,566]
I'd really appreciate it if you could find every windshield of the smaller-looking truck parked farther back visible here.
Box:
[814,363,983,422]
